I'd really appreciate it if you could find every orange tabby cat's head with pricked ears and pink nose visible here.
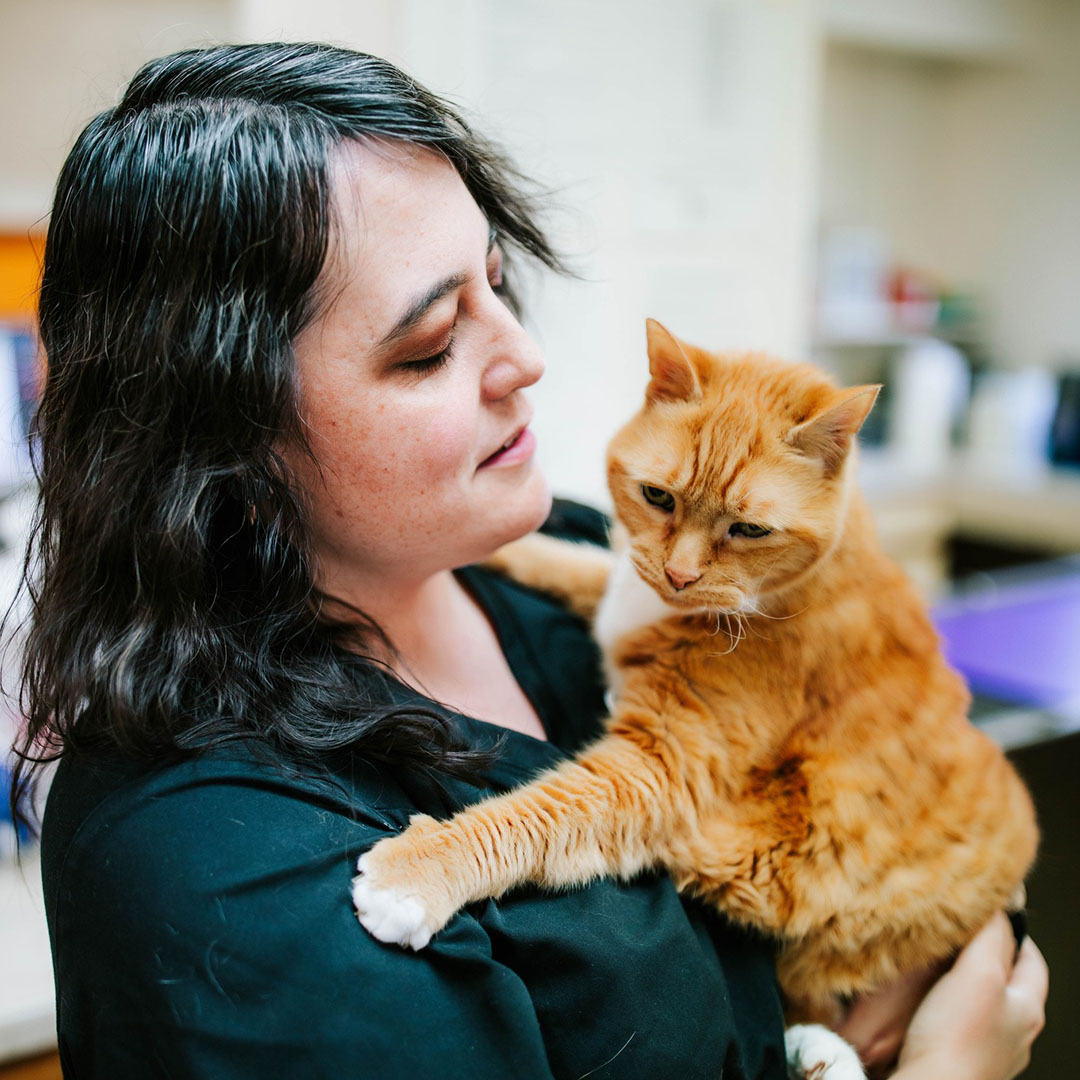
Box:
[608,319,880,612]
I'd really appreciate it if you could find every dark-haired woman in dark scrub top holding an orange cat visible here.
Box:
[14,45,1044,1080]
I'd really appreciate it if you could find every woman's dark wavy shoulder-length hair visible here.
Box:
[13,44,562,825]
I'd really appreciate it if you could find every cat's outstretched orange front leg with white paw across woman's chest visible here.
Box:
[353,735,671,949]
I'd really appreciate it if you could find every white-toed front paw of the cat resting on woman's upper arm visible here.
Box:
[352,814,457,949]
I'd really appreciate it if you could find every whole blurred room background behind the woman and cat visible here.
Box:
[0,0,1080,1077]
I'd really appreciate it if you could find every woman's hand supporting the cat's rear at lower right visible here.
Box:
[893,913,1049,1080]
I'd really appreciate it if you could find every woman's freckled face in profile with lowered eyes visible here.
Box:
[292,143,551,605]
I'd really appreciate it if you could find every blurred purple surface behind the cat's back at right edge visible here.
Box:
[934,572,1080,707]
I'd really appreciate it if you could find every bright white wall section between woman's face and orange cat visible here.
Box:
[472,0,818,501]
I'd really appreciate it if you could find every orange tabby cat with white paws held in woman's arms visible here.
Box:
[354,320,1037,1071]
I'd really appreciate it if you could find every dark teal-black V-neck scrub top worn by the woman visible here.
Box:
[42,507,786,1080]
